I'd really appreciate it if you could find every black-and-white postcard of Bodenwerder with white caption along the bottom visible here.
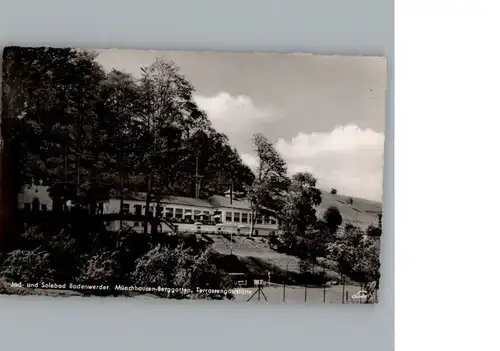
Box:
[0,47,387,304]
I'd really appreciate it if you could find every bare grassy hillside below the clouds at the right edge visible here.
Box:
[317,191,382,228]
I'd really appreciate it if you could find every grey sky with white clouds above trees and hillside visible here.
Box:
[97,49,387,201]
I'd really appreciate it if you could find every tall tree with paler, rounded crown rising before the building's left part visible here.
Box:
[137,60,204,234]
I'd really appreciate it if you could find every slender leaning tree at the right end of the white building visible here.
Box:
[248,134,290,235]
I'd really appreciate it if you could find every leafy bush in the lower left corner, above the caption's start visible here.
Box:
[0,249,55,283]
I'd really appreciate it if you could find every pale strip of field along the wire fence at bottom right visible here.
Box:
[235,285,368,304]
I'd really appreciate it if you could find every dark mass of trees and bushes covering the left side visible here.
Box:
[2,47,246,300]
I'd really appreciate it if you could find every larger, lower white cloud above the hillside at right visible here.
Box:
[242,125,384,201]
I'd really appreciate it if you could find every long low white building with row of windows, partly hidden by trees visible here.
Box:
[19,186,278,236]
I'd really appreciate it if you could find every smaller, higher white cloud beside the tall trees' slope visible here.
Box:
[194,92,278,137]
